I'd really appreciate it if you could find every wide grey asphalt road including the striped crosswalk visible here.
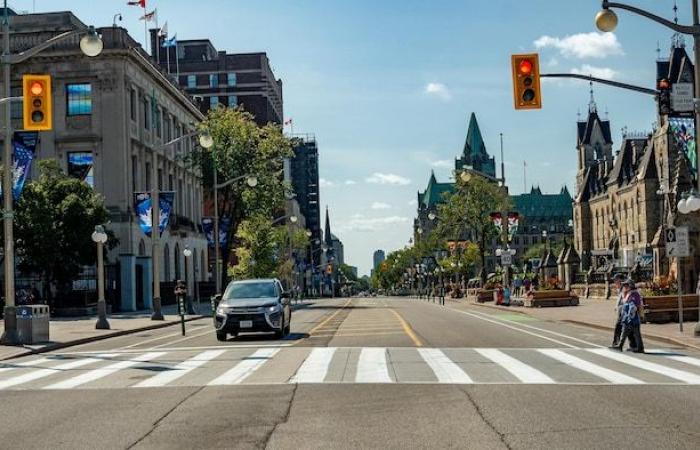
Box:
[0,298,700,449]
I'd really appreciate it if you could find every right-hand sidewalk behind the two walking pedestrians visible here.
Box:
[469,298,700,350]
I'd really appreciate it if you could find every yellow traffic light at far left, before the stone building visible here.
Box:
[22,75,53,131]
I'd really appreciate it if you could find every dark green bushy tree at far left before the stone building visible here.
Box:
[14,160,116,297]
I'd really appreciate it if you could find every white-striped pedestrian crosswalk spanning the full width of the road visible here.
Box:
[0,347,700,389]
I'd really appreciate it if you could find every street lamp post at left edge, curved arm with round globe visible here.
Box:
[0,8,103,345]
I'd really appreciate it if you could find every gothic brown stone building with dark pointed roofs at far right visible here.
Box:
[574,39,700,291]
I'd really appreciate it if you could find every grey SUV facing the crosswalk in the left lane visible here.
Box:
[214,278,292,341]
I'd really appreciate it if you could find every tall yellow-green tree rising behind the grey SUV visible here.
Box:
[192,107,293,285]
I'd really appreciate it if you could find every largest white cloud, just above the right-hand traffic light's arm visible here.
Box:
[535,32,624,59]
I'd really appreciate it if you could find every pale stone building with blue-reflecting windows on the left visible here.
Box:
[0,12,208,311]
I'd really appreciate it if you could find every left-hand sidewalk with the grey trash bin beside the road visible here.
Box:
[0,303,211,361]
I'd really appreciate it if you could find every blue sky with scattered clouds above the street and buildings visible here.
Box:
[17,0,692,274]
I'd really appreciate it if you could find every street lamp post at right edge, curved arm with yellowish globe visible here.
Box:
[595,0,700,336]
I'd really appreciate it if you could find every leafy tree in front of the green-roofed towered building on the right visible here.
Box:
[436,175,511,281]
